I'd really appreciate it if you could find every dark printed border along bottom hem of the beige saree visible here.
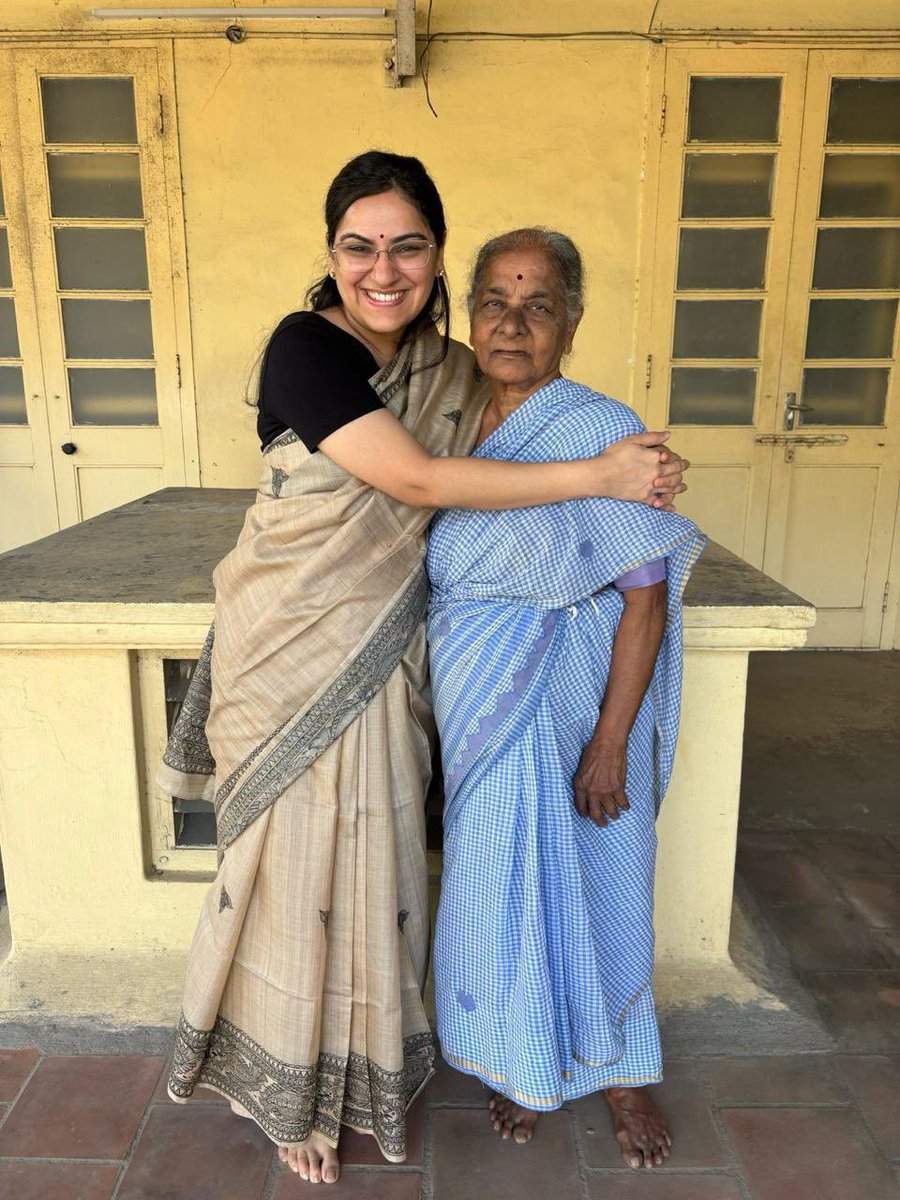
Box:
[169,1014,434,1159]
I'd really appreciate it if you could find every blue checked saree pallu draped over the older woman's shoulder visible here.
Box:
[428,378,706,824]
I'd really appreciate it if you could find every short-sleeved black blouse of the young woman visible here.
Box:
[257,312,384,451]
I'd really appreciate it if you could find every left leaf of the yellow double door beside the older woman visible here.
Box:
[647,49,805,566]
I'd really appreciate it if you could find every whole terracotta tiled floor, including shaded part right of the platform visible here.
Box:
[0,655,900,1200]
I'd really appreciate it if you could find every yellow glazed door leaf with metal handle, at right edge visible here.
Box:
[763,50,900,647]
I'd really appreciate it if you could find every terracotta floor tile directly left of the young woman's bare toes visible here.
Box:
[116,1104,275,1200]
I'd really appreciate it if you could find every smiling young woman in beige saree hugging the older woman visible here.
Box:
[160,151,684,1182]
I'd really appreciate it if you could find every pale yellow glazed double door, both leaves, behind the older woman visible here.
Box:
[648,48,900,647]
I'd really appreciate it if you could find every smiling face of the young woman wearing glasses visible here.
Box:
[331,192,443,354]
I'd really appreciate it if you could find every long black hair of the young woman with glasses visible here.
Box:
[306,150,450,366]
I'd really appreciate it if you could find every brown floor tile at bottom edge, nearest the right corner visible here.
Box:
[722,1109,896,1200]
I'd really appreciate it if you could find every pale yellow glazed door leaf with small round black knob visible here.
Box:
[0,48,197,541]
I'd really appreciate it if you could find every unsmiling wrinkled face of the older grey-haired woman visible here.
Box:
[469,250,577,397]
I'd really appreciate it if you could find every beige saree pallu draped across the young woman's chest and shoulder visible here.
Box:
[157,329,478,846]
